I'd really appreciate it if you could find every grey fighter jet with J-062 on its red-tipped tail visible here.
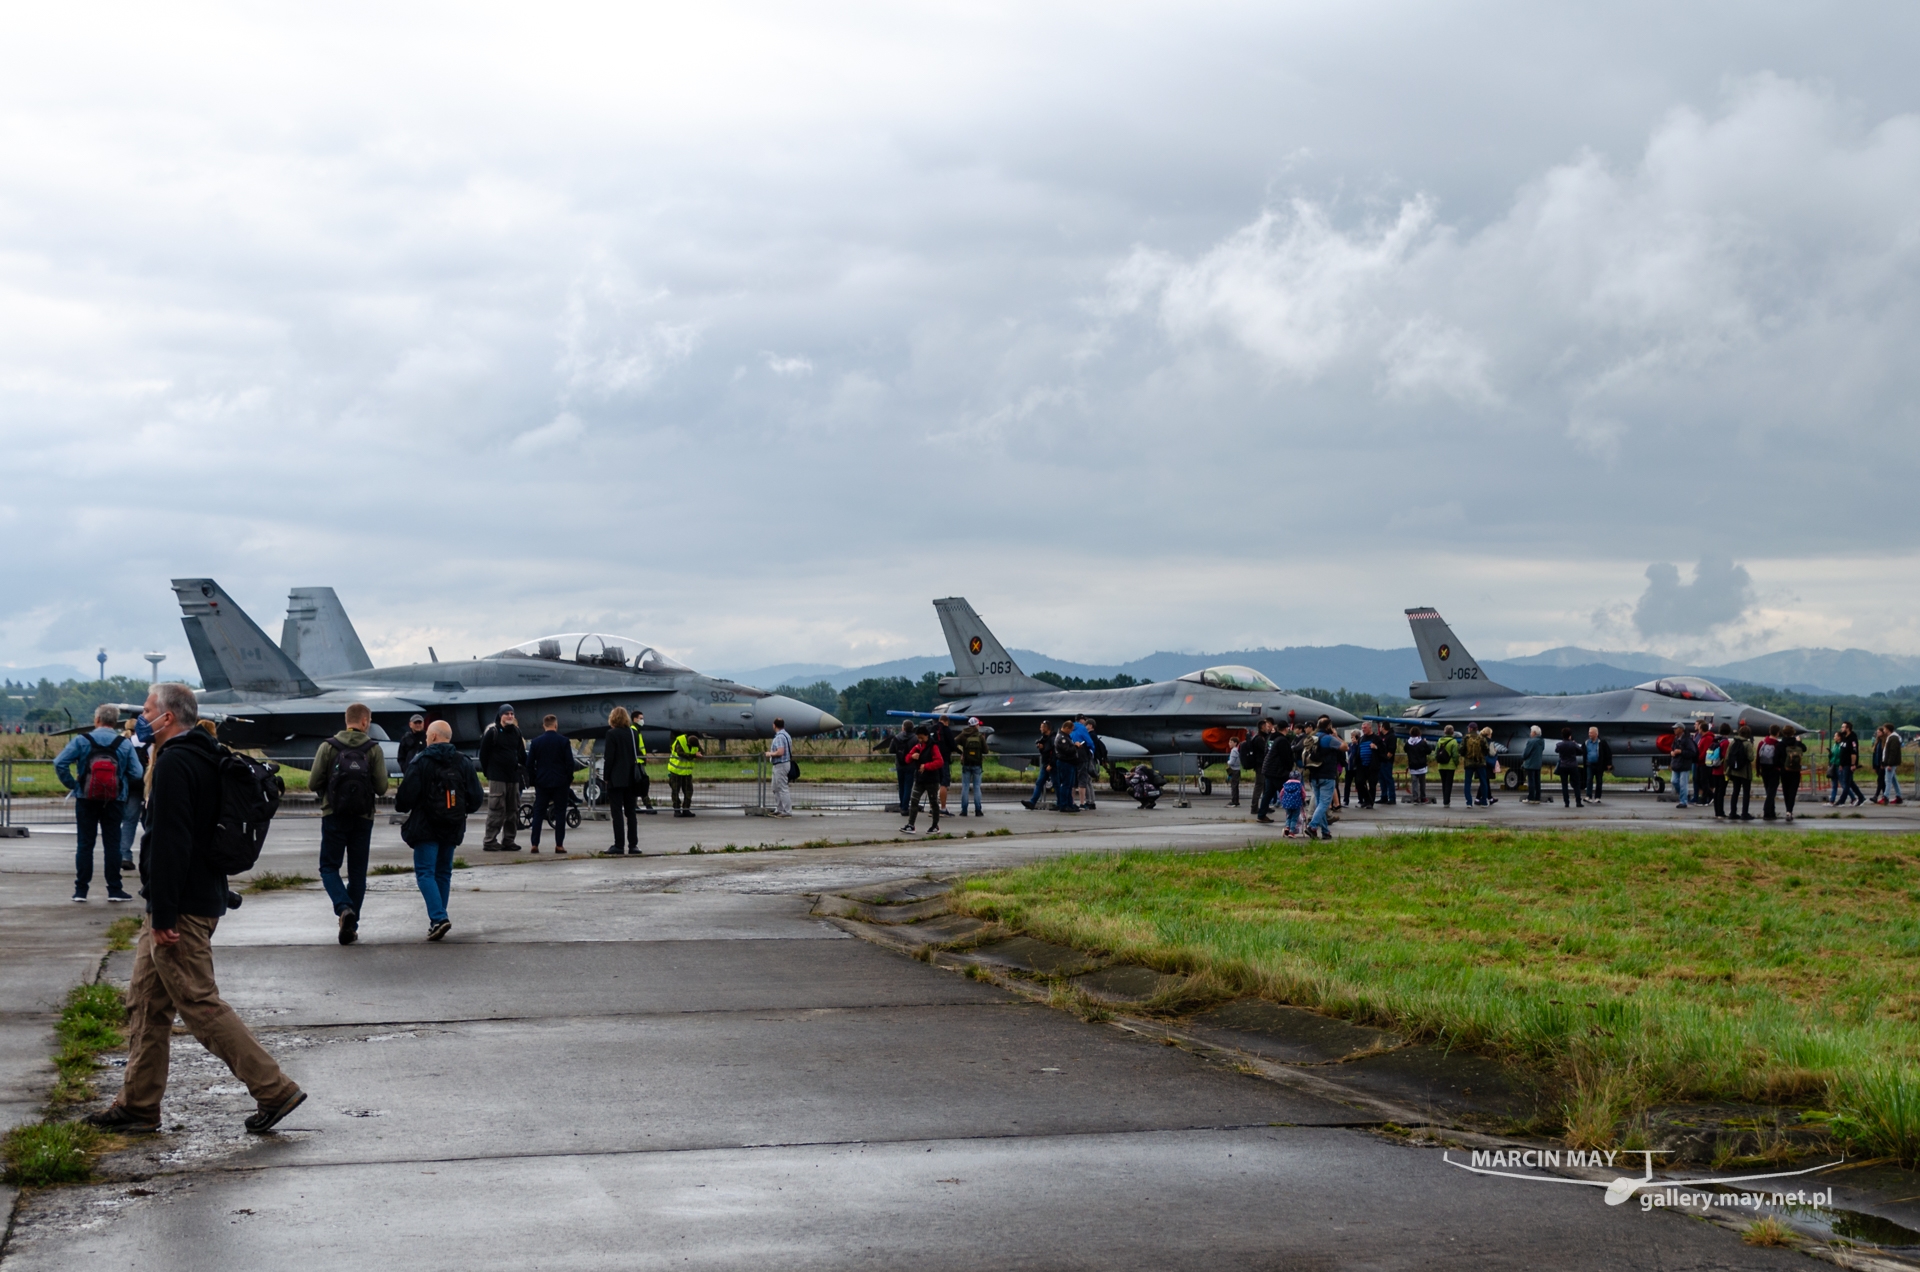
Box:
[1371,605,1799,790]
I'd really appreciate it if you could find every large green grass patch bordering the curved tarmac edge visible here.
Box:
[954,832,1920,1162]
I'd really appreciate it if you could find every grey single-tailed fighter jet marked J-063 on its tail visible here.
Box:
[917,596,1359,787]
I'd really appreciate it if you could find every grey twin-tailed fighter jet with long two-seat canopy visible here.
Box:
[173,578,841,769]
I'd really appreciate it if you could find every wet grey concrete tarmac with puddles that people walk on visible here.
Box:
[0,794,1889,1270]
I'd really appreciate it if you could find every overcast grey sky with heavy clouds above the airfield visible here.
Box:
[0,0,1920,687]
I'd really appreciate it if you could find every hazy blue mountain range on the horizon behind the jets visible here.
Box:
[714,646,1920,697]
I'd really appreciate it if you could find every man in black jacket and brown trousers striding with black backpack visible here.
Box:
[86,682,307,1134]
